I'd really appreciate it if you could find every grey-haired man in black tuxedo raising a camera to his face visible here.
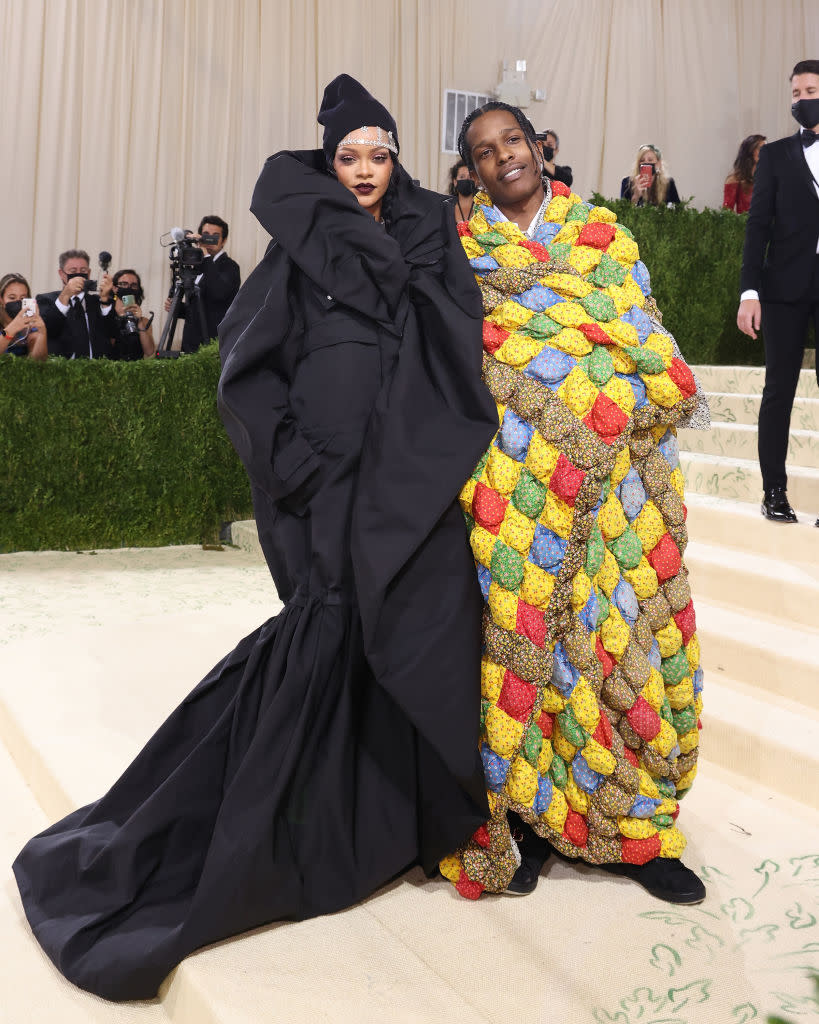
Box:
[37,249,117,359]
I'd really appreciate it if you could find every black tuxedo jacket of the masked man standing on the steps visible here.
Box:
[739,132,819,302]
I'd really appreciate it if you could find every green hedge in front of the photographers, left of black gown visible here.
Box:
[0,344,251,551]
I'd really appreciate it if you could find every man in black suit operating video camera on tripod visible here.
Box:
[165,214,242,352]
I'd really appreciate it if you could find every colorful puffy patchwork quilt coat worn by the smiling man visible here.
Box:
[441,181,702,898]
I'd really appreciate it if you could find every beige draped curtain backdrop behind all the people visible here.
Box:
[0,0,819,327]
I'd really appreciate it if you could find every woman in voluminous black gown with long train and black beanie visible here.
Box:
[14,76,497,999]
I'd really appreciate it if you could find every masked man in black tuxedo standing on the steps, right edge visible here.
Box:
[736,60,819,526]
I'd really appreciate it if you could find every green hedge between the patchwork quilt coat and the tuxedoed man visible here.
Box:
[594,196,765,366]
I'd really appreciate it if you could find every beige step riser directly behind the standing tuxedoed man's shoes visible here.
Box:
[680,452,819,509]
